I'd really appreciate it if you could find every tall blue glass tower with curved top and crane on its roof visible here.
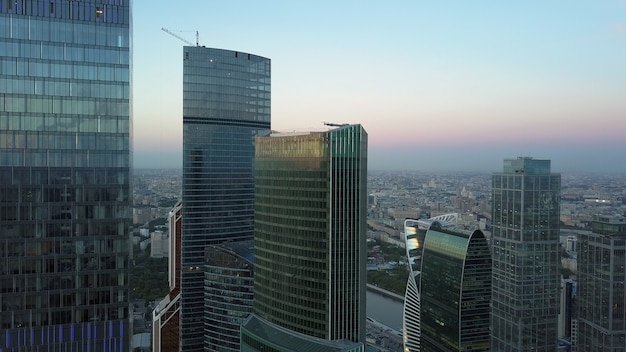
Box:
[181,46,270,351]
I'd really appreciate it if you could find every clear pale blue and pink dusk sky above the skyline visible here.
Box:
[133,0,626,173]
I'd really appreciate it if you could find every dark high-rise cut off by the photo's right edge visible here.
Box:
[573,215,626,352]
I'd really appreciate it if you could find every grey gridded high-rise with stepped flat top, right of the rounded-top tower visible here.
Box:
[491,157,561,352]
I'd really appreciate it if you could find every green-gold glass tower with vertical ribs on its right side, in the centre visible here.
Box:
[241,125,367,351]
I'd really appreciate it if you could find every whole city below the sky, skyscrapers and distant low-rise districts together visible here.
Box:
[0,0,626,352]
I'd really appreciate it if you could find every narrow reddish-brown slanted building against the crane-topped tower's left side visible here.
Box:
[152,201,183,352]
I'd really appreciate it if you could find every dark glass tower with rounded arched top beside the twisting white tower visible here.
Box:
[420,227,491,352]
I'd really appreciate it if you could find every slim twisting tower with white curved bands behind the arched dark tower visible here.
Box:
[402,213,458,352]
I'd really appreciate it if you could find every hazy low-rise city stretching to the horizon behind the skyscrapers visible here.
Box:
[133,169,626,351]
